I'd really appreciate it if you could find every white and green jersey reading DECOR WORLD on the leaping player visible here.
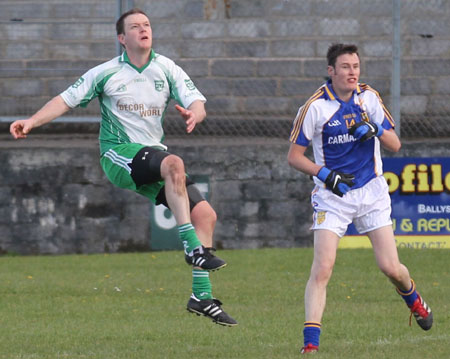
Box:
[61,50,206,154]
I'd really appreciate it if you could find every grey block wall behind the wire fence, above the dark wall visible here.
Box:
[0,0,450,136]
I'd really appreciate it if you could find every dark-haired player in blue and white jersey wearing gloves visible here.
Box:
[288,44,433,353]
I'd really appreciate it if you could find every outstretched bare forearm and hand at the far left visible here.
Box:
[9,95,70,139]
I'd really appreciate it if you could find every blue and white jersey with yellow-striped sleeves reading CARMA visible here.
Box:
[290,81,394,189]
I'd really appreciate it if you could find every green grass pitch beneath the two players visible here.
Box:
[0,248,450,359]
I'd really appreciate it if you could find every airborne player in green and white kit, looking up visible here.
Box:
[10,9,237,326]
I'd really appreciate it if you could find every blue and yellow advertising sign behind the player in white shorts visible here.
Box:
[340,157,450,248]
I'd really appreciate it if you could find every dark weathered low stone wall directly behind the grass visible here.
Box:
[0,129,449,254]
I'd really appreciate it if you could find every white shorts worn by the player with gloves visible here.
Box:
[311,176,392,237]
